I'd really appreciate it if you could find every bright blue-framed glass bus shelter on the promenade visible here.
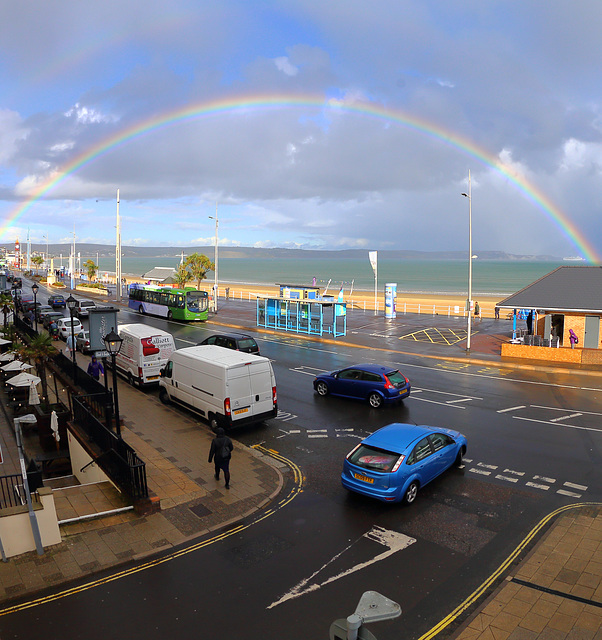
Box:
[257,296,347,338]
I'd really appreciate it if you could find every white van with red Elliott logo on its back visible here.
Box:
[115,323,176,386]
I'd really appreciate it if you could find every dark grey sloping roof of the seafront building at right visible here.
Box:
[497,266,602,314]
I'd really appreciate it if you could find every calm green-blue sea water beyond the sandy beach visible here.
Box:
[93,255,571,295]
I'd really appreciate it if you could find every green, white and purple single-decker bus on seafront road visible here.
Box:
[128,283,209,322]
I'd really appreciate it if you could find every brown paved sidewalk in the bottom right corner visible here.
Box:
[453,506,602,640]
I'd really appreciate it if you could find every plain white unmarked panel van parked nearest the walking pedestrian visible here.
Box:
[159,345,278,430]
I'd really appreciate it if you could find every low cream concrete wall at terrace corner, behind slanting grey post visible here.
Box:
[0,487,61,558]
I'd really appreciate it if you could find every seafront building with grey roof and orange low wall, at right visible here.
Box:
[497,266,602,365]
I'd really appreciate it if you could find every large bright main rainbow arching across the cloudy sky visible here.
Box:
[0,95,600,264]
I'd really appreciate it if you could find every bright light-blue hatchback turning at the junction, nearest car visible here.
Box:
[341,422,468,504]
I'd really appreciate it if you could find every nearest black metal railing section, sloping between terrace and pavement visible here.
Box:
[73,392,148,500]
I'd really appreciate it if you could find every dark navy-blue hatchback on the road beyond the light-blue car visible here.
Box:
[314,364,411,409]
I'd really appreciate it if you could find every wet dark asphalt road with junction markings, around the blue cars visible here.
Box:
[0,294,602,640]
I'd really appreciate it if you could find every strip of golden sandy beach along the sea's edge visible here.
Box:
[116,276,496,318]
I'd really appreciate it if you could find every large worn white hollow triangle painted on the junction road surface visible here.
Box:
[267,526,416,609]
